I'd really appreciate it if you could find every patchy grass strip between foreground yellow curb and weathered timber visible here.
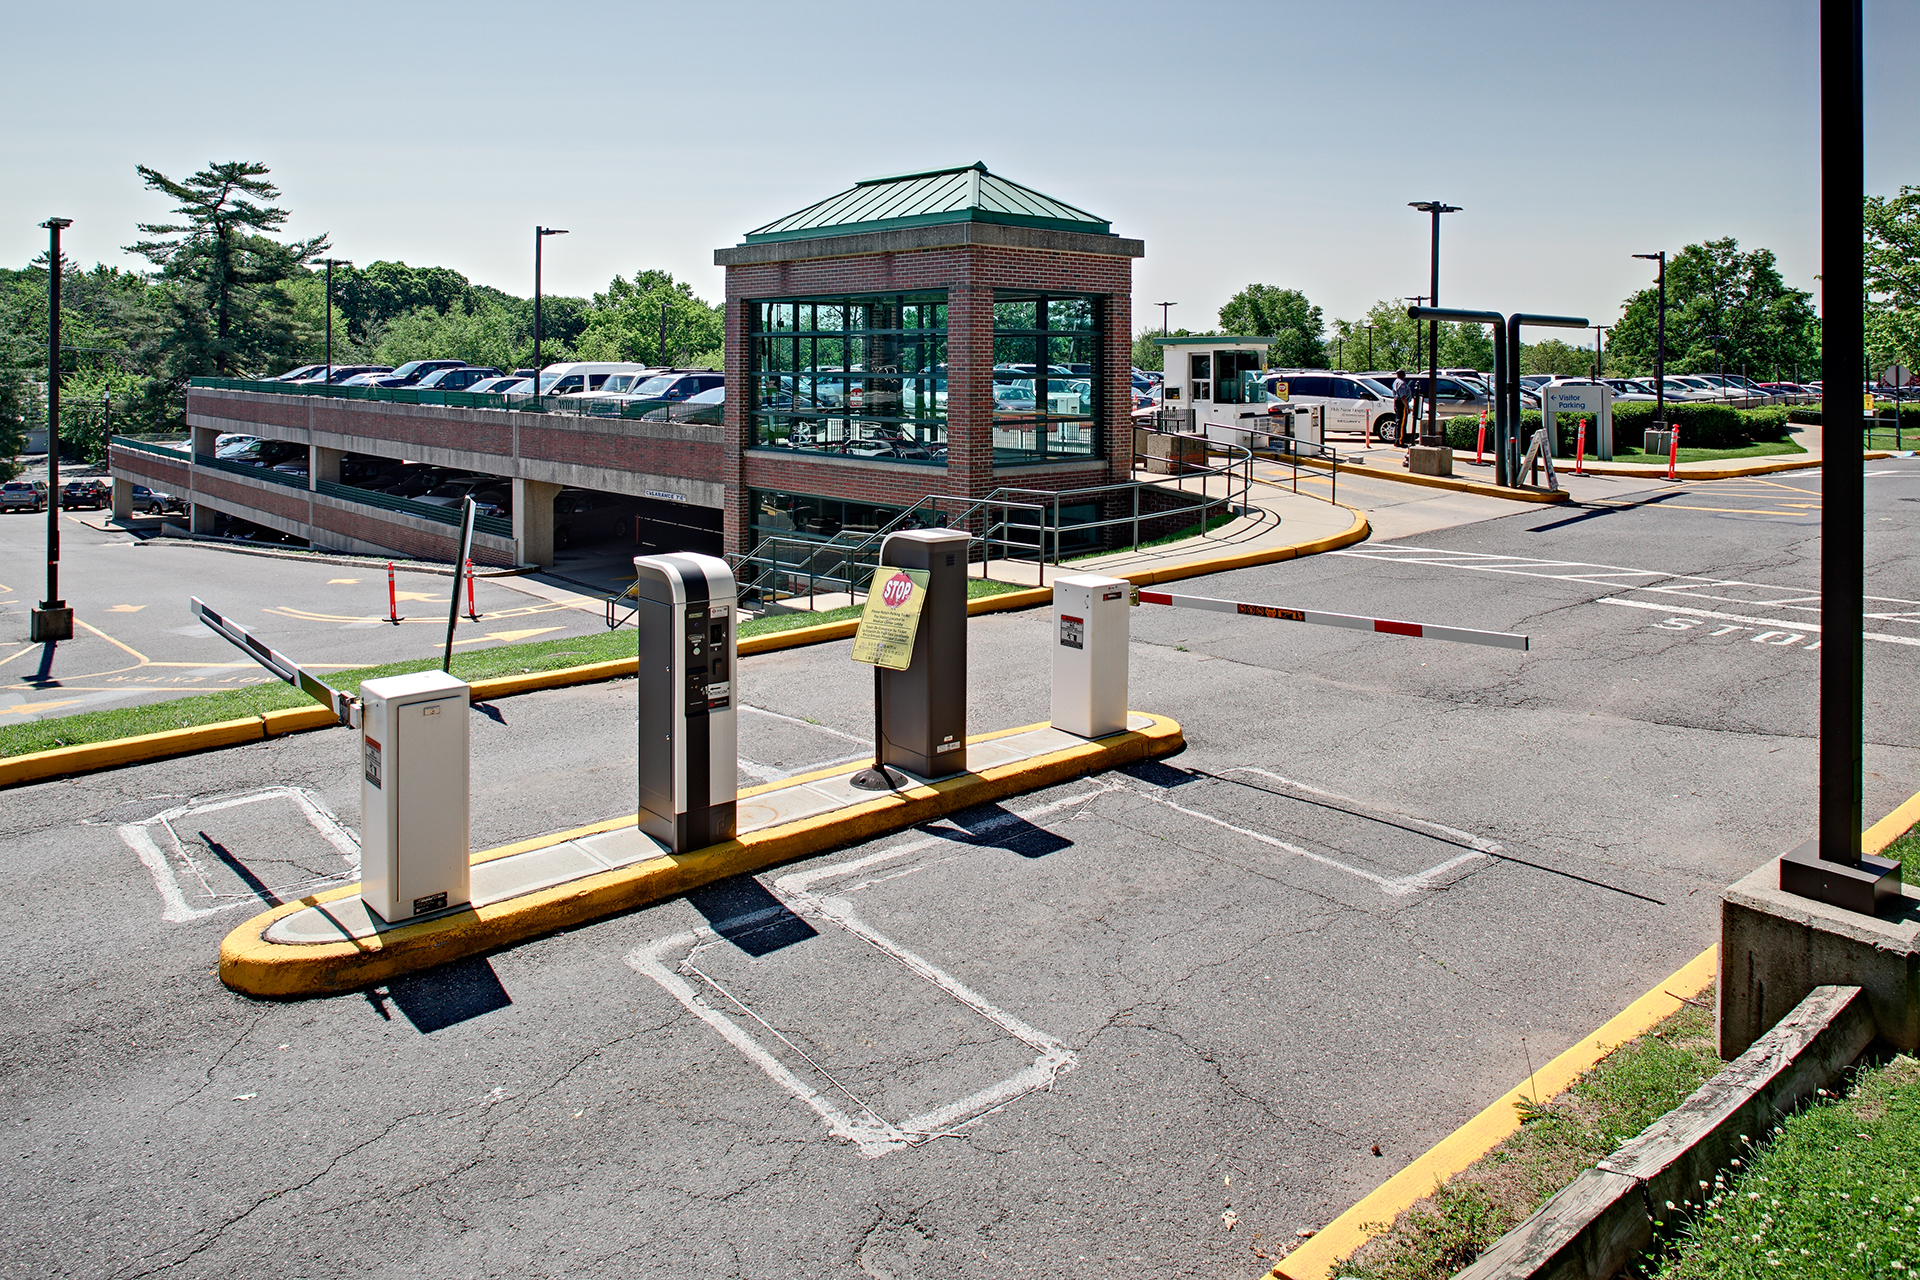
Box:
[1338,988,1724,1280]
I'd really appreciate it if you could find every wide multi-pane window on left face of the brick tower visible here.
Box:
[747,292,947,470]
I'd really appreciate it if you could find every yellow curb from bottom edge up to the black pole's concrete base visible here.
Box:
[1267,946,1720,1280]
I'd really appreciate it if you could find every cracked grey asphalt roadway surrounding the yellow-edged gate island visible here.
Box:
[0,461,1920,1280]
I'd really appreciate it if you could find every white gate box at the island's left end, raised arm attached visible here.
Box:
[361,672,472,925]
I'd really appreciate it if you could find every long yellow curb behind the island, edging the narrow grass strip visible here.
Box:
[0,503,1373,787]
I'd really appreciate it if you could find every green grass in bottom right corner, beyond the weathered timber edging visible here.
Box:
[1642,1054,1920,1280]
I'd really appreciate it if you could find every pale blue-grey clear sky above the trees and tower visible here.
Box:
[0,0,1920,345]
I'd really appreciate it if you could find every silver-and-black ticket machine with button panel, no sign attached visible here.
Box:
[634,553,739,854]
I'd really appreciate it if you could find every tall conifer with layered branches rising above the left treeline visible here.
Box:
[127,161,328,382]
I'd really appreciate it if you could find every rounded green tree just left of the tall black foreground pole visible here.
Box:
[1607,236,1820,376]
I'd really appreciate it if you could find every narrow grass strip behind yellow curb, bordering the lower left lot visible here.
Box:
[0,578,1025,756]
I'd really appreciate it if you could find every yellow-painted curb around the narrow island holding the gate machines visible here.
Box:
[219,716,1187,1000]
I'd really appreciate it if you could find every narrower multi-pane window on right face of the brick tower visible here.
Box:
[993,290,1102,466]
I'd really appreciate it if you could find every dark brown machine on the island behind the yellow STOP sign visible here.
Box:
[876,530,970,777]
